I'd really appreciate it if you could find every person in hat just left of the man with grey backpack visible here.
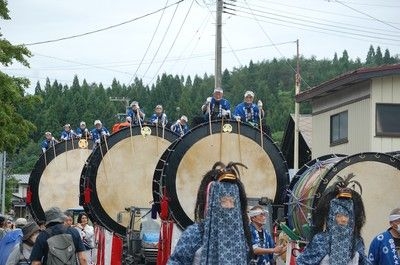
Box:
[6,219,40,265]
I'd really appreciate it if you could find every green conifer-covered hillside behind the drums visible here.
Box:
[6,46,400,173]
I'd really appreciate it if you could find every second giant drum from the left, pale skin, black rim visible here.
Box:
[80,125,178,236]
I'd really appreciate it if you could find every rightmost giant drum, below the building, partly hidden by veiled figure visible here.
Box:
[286,153,400,247]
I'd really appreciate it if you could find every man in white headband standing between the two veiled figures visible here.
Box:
[248,205,285,265]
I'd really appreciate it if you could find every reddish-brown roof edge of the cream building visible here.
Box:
[296,64,400,103]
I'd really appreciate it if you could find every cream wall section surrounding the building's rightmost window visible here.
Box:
[370,76,400,153]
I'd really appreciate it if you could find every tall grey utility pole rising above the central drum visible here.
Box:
[215,0,224,88]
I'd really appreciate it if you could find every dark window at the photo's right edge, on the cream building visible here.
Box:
[375,103,400,137]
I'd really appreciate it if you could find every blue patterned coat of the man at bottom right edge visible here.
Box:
[368,231,400,265]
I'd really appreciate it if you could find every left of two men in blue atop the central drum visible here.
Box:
[201,87,231,121]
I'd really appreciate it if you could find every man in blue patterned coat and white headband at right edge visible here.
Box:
[368,208,400,265]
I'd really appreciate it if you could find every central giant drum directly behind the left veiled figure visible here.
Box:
[153,120,289,228]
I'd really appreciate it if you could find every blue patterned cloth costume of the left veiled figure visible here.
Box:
[167,182,248,265]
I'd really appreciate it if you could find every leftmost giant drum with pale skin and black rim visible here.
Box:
[27,139,93,221]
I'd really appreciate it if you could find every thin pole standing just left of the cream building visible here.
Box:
[293,40,301,173]
